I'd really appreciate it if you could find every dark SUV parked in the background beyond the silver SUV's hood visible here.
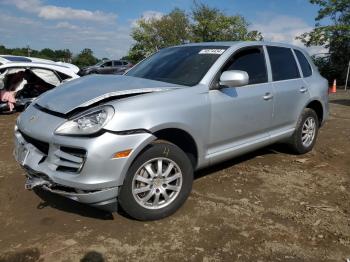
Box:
[78,60,133,76]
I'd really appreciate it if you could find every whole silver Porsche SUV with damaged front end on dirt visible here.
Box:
[15,42,328,220]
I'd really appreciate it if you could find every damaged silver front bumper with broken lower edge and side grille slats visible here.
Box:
[14,107,155,211]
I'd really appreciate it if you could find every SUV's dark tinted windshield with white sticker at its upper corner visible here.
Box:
[126,46,228,86]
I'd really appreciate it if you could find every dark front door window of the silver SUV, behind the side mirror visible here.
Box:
[222,47,267,85]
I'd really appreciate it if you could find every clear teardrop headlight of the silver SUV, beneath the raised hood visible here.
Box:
[55,106,114,135]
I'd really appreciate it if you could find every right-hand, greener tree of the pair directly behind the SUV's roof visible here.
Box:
[191,2,263,42]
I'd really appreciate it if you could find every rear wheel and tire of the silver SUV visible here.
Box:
[290,108,319,154]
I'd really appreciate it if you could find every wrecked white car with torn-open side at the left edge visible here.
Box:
[0,62,79,112]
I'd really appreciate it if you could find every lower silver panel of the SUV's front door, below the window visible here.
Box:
[208,83,273,159]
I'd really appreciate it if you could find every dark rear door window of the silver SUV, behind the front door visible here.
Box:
[267,46,300,81]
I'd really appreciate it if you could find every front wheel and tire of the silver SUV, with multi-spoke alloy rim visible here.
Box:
[118,141,193,221]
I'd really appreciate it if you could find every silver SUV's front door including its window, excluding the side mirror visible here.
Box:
[208,46,273,155]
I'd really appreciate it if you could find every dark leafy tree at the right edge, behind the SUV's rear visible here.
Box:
[297,0,350,83]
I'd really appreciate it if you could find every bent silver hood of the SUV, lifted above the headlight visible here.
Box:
[35,75,182,114]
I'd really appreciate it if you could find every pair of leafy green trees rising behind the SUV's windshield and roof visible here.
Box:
[125,2,262,63]
